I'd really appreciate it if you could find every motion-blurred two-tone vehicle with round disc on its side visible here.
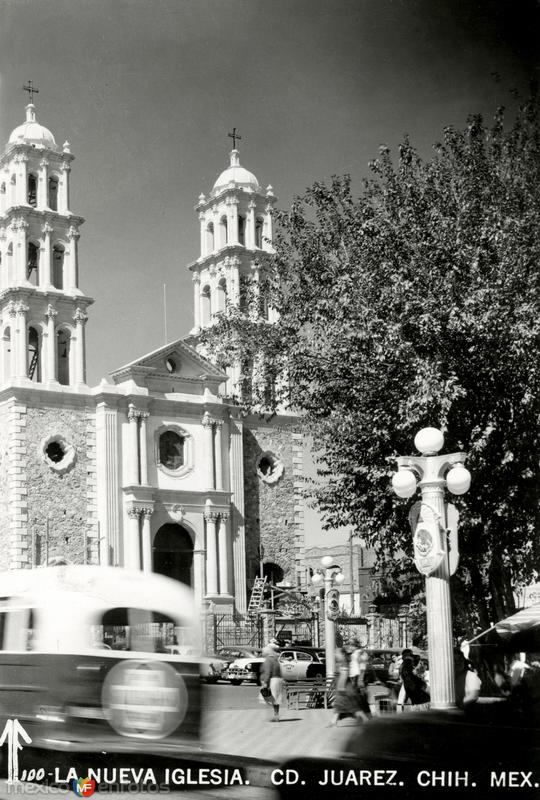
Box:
[0,565,200,753]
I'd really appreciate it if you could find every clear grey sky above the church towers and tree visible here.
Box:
[0,0,538,384]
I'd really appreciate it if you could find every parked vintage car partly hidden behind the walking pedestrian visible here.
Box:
[227,647,326,686]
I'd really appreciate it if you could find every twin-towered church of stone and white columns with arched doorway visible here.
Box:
[0,103,305,614]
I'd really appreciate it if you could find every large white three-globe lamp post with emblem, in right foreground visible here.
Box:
[392,428,471,709]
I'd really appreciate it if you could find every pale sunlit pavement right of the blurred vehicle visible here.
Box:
[201,705,352,763]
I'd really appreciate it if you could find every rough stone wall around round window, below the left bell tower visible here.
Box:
[26,407,97,565]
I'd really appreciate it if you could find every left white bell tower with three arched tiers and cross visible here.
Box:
[0,92,93,388]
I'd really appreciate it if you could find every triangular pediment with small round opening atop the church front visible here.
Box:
[111,339,227,388]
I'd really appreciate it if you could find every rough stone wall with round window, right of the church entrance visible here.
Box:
[243,419,304,585]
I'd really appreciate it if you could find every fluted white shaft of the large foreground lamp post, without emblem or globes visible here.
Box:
[420,478,456,709]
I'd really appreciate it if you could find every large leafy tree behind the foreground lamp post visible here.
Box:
[201,97,540,628]
